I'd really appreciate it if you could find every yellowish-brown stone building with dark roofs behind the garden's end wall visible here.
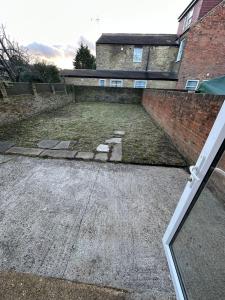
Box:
[61,34,179,89]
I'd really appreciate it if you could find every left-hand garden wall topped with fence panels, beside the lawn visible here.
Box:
[0,83,74,126]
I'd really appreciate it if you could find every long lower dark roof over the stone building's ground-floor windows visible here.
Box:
[60,69,177,81]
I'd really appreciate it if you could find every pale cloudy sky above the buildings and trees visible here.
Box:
[0,0,191,69]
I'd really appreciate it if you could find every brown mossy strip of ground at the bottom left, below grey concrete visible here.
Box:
[0,272,127,300]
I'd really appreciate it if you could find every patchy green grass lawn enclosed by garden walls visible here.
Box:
[0,103,186,166]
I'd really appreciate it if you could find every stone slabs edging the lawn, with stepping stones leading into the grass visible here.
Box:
[0,130,125,162]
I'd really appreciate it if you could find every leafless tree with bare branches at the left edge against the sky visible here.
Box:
[0,25,29,81]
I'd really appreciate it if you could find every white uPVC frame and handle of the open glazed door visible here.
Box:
[162,101,225,300]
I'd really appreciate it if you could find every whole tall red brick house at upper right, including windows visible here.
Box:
[177,0,225,90]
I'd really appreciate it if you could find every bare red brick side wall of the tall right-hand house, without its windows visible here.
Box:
[177,1,225,89]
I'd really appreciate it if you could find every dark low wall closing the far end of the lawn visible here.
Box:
[74,86,143,103]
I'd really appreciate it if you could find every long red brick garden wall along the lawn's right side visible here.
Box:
[142,90,224,163]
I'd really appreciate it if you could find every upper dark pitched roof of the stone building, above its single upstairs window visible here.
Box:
[96,33,178,46]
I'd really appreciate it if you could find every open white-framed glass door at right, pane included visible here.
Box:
[163,104,225,300]
